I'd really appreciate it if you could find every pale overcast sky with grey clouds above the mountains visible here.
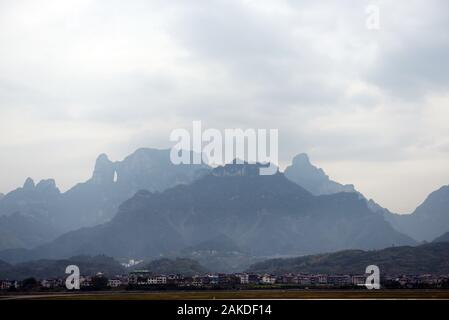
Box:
[0,0,449,213]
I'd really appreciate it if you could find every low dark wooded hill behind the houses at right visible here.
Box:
[248,242,449,275]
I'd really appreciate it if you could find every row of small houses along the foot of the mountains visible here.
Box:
[0,270,449,290]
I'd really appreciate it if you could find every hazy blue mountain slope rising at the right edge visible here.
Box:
[386,186,449,241]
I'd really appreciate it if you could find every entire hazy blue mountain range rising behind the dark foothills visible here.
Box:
[0,149,449,271]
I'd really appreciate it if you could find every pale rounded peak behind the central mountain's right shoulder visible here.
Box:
[284,153,356,195]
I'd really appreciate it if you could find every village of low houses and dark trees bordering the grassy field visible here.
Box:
[0,270,449,292]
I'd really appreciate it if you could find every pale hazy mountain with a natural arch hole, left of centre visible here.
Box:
[0,149,209,249]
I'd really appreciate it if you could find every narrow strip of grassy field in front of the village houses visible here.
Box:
[0,290,449,300]
